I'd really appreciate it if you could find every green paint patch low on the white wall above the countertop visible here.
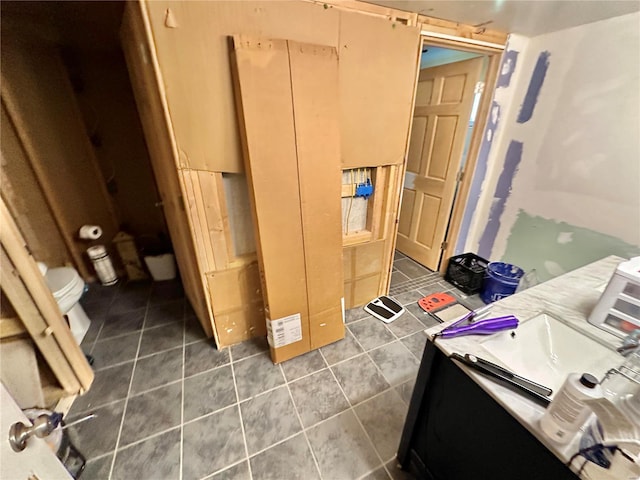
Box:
[501,210,640,282]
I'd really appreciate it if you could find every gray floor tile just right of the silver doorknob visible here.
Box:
[67,400,124,460]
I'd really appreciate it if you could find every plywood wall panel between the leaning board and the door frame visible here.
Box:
[339,12,420,167]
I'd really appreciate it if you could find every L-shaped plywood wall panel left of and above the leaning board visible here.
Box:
[146,1,339,172]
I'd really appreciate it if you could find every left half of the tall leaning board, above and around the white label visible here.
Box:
[234,37,310,361]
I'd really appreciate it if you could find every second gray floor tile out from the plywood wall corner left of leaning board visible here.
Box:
[184,365,236,422]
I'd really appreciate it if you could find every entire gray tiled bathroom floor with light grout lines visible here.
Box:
[67,253,477,480]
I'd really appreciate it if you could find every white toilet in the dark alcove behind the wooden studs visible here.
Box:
[38,262,91,345]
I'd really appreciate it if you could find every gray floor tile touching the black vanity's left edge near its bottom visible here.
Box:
[354,390,407,461]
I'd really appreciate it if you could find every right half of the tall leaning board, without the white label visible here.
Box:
[288,42,344,349]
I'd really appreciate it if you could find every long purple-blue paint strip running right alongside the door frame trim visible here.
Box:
[454,101,500,255]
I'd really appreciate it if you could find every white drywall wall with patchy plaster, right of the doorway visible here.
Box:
[466,13,640,259]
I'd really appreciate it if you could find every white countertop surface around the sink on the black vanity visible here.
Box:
[426,256,624,478]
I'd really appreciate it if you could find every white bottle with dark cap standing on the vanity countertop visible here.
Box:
[540,373,602,443]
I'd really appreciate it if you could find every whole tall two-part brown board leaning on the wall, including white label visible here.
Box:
[232,36,344,363]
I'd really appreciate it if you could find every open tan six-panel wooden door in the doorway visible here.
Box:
[396,58,483,270]
